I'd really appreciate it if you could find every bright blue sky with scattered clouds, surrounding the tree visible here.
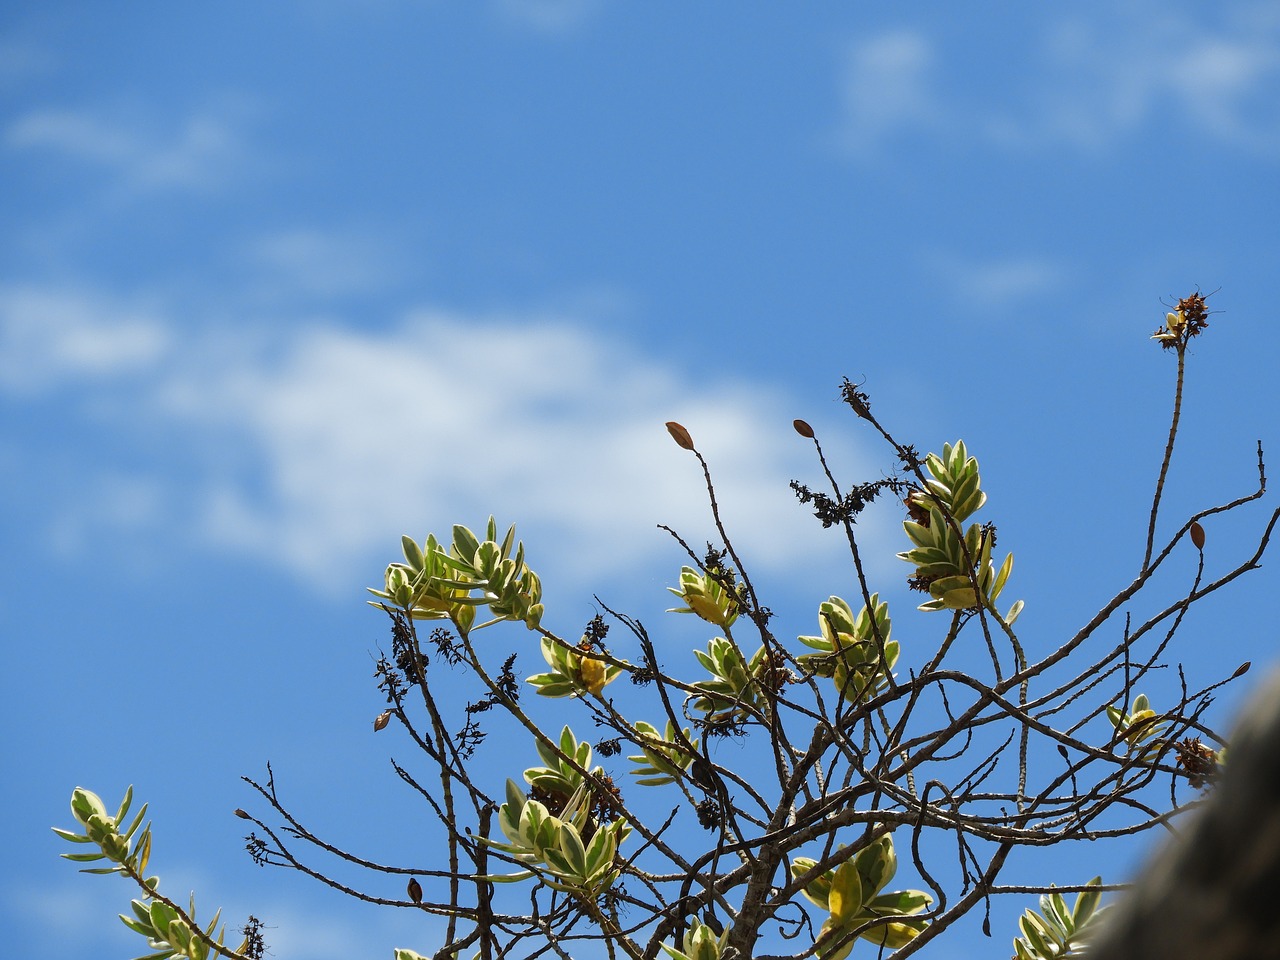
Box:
[0,0,1280,960]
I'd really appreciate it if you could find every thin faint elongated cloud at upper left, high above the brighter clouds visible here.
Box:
[4,109,248,189]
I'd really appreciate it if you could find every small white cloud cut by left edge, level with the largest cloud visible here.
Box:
[0,287,170,393]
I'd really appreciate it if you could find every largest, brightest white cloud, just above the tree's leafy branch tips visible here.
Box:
[165,311,844,591]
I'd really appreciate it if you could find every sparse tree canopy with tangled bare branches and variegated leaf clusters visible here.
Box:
[58,293,1280,960]
